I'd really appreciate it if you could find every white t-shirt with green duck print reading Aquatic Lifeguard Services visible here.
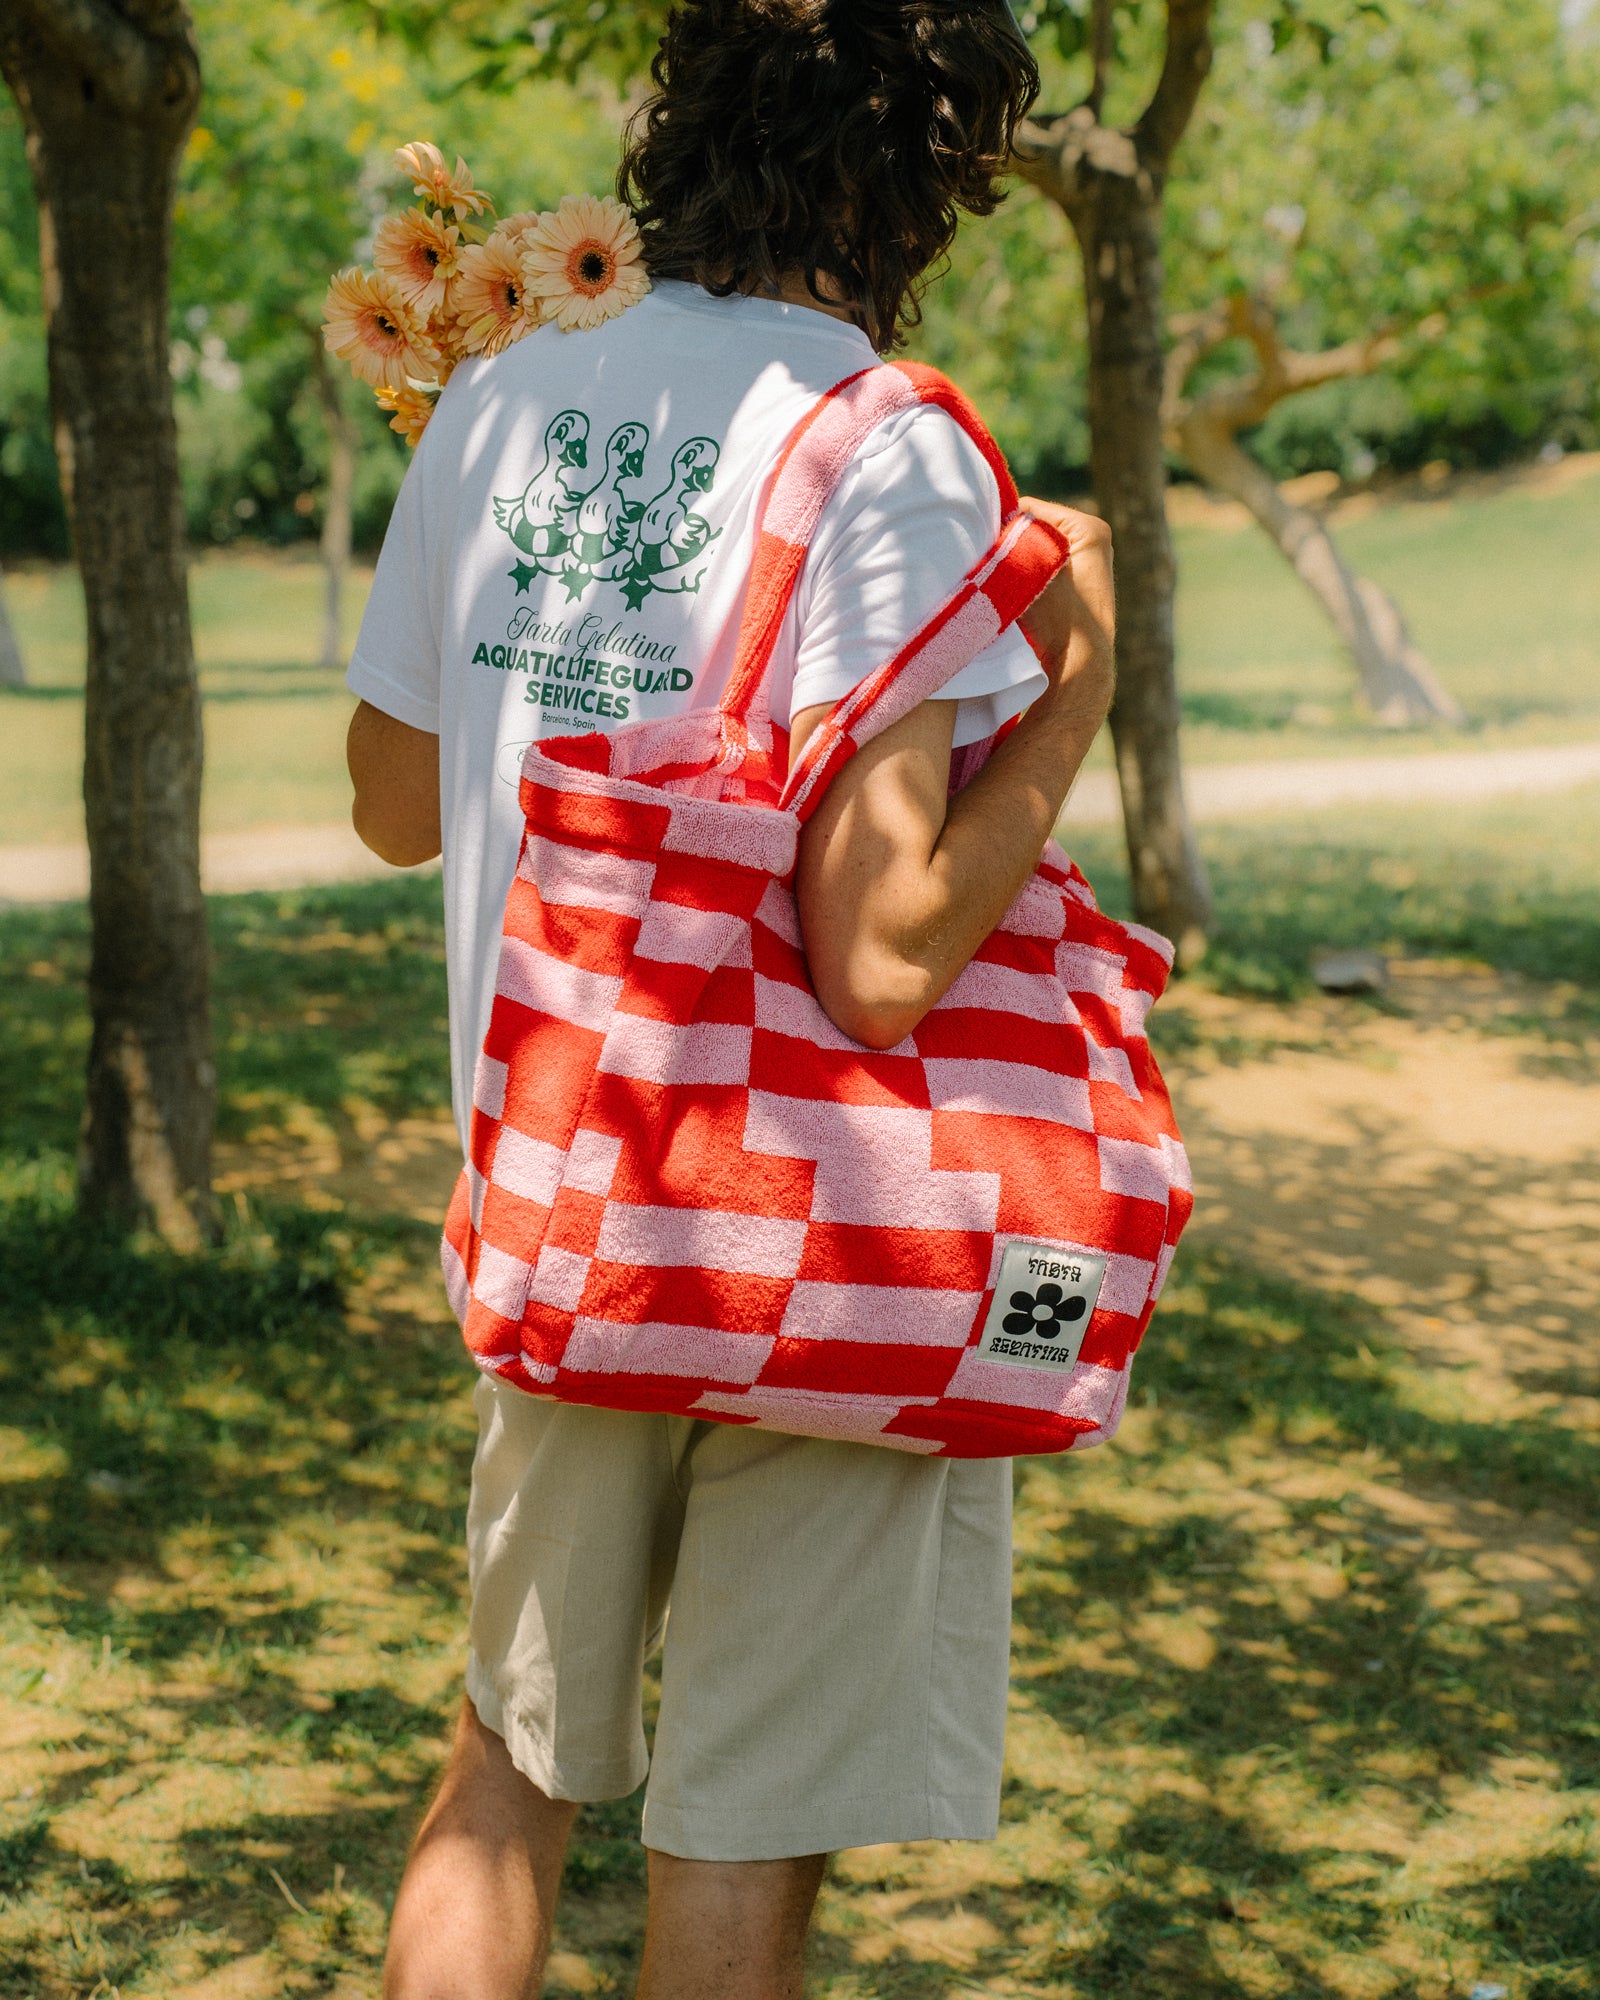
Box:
[348,284,1044,1142]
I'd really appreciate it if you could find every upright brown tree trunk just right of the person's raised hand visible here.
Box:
[1070,174,1212,966]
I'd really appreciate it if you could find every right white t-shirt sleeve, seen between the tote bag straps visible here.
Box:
[774,404,1048,746]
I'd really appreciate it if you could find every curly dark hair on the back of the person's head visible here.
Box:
[616,0,1038,352]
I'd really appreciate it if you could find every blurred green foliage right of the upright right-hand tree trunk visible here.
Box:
[1168,0,1600,476]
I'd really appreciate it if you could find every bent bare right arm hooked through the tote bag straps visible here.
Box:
[792,500,1116,1048]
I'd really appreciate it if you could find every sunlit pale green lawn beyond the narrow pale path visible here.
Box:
[0,458,1600,844]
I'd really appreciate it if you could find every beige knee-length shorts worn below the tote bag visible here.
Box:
[466,1378,1012,1860]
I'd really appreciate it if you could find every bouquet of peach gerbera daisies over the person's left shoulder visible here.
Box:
[322,140,650,444]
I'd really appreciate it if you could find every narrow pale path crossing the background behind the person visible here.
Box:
[0,744,1600,904]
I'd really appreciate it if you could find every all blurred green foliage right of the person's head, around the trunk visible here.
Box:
[916,0,1600,492]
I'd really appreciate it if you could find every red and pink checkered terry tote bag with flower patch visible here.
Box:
[442,366,1190,1458]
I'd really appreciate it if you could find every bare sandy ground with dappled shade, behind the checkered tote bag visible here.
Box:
[220,960,1600,1424]
